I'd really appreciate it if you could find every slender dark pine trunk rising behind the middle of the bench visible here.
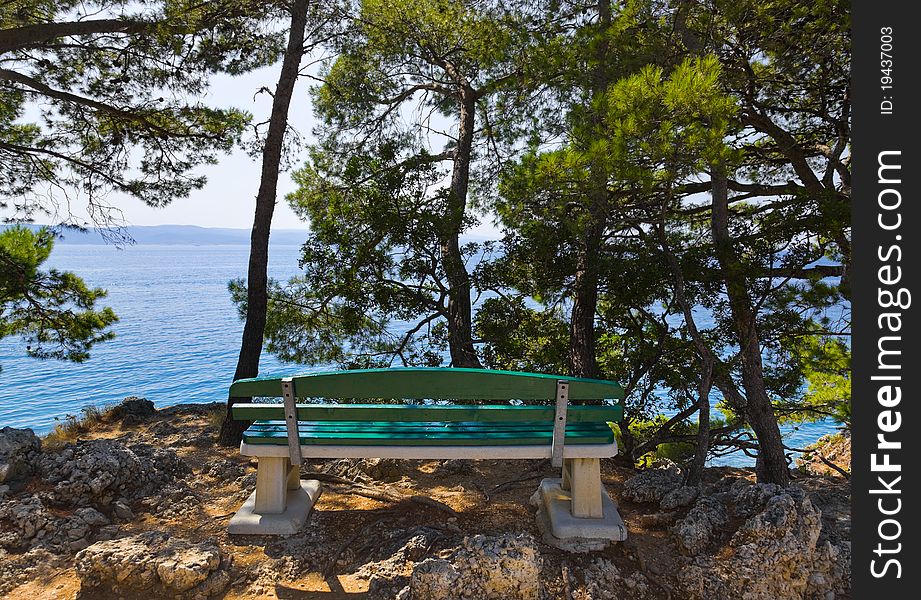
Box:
[441,86,482,369]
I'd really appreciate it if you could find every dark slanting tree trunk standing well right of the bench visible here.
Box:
[710,168,790,486]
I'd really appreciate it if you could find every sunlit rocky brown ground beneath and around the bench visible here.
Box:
[0,399,850,600]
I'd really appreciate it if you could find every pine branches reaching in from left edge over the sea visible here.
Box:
[0,0,282,360]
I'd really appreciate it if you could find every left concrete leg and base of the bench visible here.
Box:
[227,456,321,535]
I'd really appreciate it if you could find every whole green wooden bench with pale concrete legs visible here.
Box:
[229,368,623,539]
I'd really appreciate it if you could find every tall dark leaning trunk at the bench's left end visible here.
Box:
[219,0,308,445]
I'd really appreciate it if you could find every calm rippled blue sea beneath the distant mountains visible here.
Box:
[0,245,835,465]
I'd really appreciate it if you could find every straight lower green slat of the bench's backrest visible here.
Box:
[232,404,623,423]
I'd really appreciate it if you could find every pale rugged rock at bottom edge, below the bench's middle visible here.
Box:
[398,534,541,600]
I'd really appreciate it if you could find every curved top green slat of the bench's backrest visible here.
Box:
[230,367,624,400]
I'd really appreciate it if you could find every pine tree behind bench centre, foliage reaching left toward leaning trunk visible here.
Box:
[248,0,544,366]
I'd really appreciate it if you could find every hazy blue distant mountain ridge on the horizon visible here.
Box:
[14,225,307,246]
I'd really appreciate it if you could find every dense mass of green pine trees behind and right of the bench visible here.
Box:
[250,0,850,483]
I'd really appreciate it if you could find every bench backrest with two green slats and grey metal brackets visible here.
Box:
[230,368,624,466]
